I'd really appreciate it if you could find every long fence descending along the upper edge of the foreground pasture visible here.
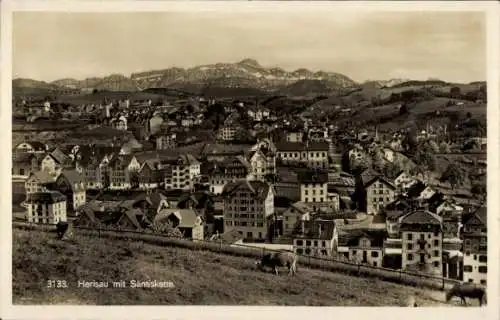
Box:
[13,221,461,290]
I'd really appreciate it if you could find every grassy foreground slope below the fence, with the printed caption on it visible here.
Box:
[13,229,458,306]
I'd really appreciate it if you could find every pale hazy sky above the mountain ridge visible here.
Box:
[13,11,486,82]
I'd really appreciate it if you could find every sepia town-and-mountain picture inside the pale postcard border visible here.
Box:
[2,0,498,318]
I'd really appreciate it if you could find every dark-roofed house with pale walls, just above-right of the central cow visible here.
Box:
[293,219,338,257]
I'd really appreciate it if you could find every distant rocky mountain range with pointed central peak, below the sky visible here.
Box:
[12,59,470,94]
